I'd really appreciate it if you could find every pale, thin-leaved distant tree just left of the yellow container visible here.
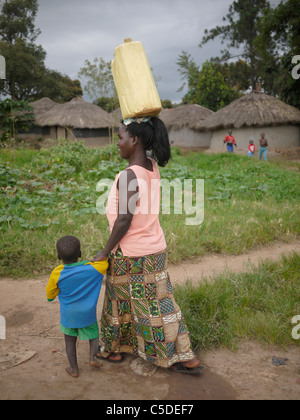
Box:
[78,57,117,100]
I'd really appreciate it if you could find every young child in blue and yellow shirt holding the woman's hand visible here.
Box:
[46,236,108,378]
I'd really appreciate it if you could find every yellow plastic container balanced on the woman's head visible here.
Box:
[111,39,162,119]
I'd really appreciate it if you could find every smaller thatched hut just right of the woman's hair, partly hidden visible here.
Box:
[159,104,214,149]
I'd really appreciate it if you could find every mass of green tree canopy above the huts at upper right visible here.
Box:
[177,0,300,110]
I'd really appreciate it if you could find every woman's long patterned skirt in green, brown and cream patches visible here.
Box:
[100,250,195,368]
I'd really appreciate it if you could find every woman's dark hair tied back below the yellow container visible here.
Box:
[126,117,171,166]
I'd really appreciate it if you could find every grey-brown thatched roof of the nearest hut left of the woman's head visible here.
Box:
[38,98,113,129]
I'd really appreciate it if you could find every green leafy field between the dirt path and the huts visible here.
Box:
[0,142,300,278]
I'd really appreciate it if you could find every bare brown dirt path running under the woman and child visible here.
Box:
[0,240,300,400]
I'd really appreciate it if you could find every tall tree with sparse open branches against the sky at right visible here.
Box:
[199,0,276,89]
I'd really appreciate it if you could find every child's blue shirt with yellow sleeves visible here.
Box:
[46,261,108,328]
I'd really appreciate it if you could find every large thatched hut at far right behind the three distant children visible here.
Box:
[197,91,300,152]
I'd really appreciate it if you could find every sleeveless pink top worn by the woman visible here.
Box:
[106,159,167,257]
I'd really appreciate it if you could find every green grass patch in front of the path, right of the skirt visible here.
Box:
[174,254,300,350]
